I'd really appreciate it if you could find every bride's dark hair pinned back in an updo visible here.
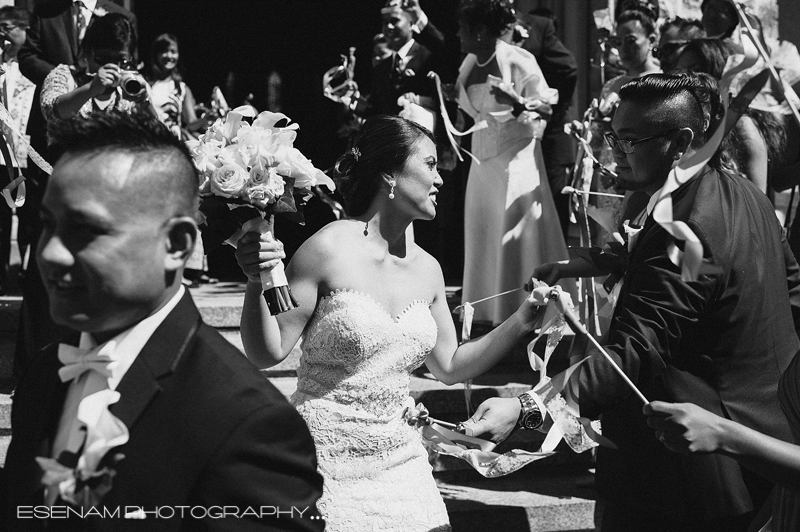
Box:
[334,115,434,216]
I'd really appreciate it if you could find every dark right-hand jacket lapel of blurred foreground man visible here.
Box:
[109,291,201,432]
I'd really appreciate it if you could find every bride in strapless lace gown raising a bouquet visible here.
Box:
[236,116,536,532]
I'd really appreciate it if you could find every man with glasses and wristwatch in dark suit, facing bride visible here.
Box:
[468,74,800,532]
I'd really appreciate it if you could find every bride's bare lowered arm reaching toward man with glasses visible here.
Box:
[425,264,540,384]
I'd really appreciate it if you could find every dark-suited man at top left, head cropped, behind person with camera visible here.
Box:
[14,0,136,384]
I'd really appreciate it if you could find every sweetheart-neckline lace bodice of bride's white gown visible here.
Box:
[297,290,437,416]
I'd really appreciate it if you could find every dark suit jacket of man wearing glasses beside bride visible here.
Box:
[579,169,800,530]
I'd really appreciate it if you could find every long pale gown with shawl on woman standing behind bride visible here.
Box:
[458,41,573,325]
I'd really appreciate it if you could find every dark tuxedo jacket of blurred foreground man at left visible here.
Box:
[0,293,324,531]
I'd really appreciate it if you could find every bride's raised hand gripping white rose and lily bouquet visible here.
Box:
[187,106,335,315]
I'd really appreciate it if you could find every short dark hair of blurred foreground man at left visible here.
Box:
[48,110,199,215]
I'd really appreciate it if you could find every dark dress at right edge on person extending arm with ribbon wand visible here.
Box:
[771,355,800,532]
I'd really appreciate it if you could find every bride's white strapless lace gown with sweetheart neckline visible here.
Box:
[292,290,450,532]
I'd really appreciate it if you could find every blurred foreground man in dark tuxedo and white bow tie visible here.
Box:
[0,113,324,531]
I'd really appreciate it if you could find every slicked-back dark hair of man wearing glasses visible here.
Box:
[619,73,725,170]
